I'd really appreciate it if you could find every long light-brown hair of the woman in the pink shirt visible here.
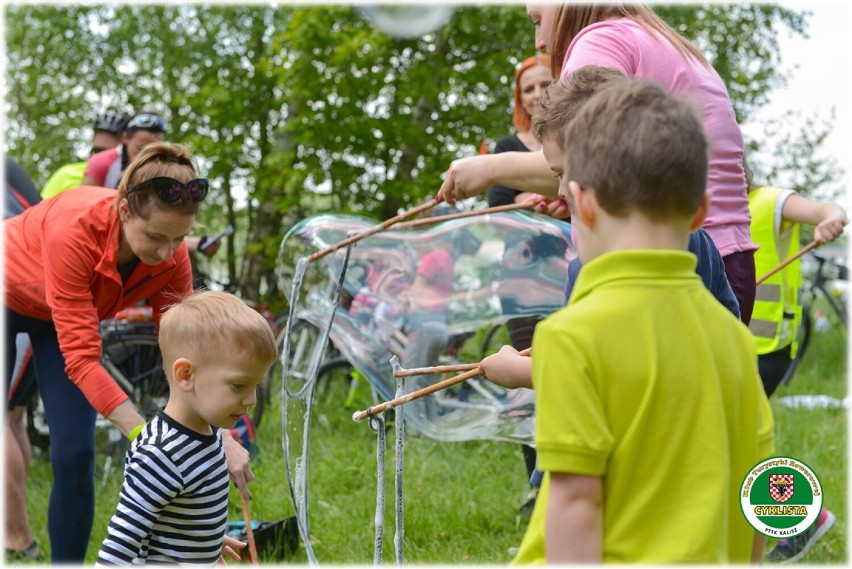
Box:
[550,2,710,77]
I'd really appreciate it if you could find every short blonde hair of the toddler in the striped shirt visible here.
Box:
[158,291,278,371]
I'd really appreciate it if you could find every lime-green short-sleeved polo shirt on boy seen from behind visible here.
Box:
[514,250,774,563]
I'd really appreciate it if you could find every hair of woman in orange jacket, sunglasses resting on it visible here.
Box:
[115,142,201,219]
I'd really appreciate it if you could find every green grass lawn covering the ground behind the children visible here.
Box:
[27,318,848,564]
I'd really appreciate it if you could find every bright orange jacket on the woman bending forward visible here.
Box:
[3,186,192,416]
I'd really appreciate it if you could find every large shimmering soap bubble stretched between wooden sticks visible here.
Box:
[277,212,575,443]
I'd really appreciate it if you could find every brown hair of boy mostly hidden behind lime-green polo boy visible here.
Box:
[532,65,625,150]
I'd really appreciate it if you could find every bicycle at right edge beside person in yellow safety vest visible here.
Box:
[781,251,849,385]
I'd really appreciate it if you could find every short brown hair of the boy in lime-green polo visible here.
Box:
[564,79,709,220]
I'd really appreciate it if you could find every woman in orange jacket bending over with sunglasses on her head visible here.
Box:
[4,143,253,563]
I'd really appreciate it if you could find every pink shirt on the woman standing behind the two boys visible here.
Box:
[561,18,757,257]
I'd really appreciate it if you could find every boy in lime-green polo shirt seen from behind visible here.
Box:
[515,80,774,563]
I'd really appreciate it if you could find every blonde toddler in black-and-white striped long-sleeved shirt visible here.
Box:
[98,291,278,565]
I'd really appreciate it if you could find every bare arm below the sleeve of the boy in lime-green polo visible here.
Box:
[544,472,603,564]
